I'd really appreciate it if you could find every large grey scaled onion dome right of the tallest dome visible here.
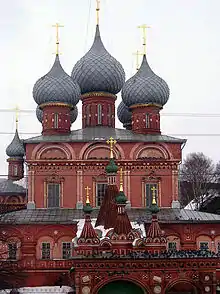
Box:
[122,55,170,107]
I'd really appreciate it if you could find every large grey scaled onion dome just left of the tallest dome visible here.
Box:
[33,55,80,105]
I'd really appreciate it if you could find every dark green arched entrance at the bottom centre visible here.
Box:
[98,281,146,294]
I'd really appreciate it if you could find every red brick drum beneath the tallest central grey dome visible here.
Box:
[82,93,116,128]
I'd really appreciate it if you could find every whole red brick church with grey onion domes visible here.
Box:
[0,7,220,294]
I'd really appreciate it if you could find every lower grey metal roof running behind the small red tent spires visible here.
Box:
[0,208,220,224]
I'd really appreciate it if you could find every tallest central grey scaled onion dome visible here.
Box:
[72,25,125,94]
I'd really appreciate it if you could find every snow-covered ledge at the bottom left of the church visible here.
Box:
[0,286,72,294]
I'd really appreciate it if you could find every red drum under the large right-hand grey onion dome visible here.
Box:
[132,105,161,134]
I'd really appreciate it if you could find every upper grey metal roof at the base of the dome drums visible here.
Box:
[24,126,186,144]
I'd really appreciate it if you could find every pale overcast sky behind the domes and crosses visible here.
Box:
[0,0,220,174]
